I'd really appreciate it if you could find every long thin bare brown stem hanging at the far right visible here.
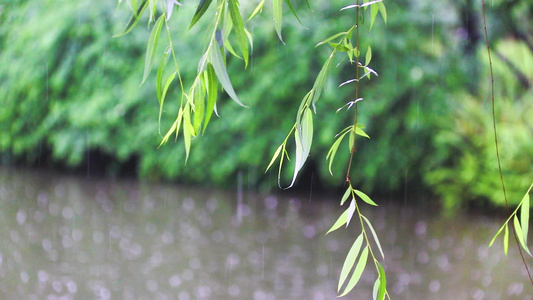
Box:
[481,0,533,285]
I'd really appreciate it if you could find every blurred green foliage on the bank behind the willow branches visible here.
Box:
[0,0,533,207]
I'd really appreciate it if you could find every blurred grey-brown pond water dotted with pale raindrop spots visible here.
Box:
[0,168,533,299]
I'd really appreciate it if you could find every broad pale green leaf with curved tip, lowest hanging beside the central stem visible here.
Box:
[289,108,313,188]
